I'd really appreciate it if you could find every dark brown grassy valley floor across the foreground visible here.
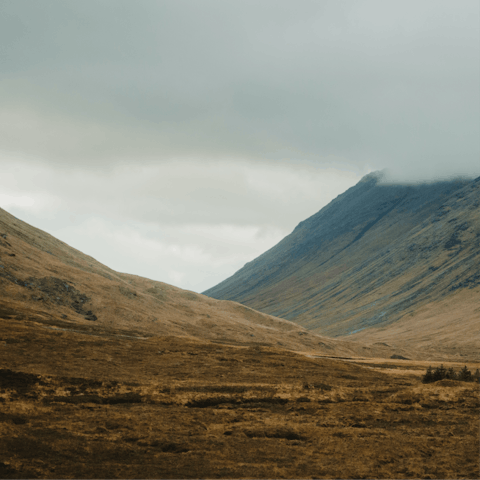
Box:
[0,316,480,480]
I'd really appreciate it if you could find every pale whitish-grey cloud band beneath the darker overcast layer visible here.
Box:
[0,157,360,234]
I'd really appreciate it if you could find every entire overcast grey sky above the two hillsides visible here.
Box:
[0,0,480,292]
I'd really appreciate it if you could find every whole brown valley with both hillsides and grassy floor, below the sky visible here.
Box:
[0,178,480,480]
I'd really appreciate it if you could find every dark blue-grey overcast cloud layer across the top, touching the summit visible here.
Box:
[0,0,480,177]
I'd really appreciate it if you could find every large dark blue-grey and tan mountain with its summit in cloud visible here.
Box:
[204,173,480,354]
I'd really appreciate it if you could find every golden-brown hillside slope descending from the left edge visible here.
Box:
[0,204,389,355]
